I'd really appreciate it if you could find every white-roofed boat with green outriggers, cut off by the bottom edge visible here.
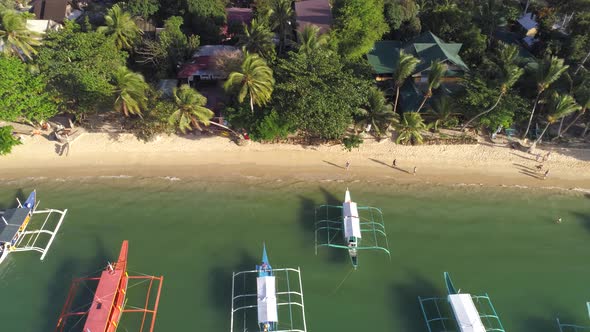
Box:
[418,272,505,332]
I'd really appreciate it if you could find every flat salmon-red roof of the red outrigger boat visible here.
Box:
[82,270,125,332]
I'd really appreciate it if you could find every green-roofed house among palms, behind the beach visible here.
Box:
[367,32,469,110]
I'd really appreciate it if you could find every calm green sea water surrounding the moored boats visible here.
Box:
[0,178,590,332]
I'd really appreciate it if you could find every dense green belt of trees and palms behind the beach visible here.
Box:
[0,0,590,152]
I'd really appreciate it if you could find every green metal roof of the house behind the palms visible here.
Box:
[367,32,469,74]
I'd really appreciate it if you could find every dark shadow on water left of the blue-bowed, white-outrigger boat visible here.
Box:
[208,250,260,330]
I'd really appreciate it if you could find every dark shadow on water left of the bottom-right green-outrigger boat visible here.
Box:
[391,272,445,332]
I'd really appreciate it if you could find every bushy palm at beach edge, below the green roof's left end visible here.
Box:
[357,87,396,139]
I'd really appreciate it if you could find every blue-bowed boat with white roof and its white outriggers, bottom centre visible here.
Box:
[230,245,307,332]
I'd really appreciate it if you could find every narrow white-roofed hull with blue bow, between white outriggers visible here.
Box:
[256,244,278,332]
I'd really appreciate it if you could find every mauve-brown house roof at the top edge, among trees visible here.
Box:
[295,0,332,33]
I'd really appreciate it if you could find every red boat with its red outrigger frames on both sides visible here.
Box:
[55,240,164,332]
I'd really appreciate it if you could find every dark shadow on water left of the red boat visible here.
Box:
[37,237,116,331]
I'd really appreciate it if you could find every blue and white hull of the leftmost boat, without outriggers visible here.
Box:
[0,190,37,263]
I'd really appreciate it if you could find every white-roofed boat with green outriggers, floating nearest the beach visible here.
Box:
[315,188,391,269]
